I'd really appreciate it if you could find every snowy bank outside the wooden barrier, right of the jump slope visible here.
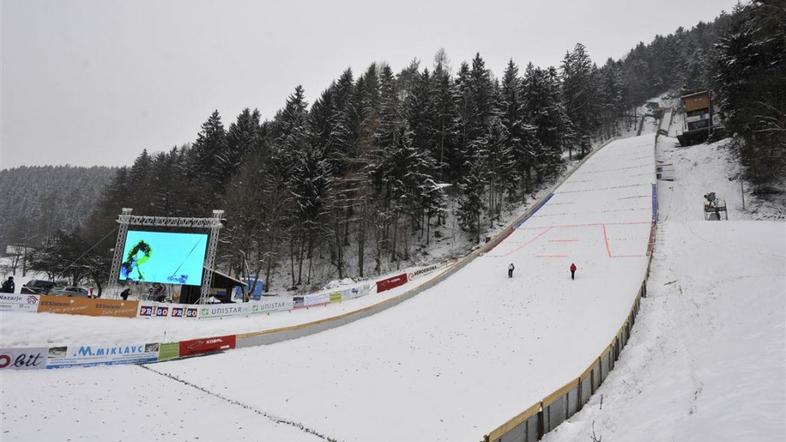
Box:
[545,137,786,442]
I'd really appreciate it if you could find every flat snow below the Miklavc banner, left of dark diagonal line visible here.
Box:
[0,365,321,442]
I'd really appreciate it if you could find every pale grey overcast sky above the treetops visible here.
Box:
[0,0,736,169]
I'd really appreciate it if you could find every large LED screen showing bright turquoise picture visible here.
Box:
[120,230,207,285]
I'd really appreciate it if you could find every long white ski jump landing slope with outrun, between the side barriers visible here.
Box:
[0,134,655,442]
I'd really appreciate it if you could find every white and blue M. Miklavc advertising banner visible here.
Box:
[46,344,159,368]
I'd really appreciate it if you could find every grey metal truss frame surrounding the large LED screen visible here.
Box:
[107,207,224,304]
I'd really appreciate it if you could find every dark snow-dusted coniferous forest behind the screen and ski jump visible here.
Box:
[9,0,786,296]
